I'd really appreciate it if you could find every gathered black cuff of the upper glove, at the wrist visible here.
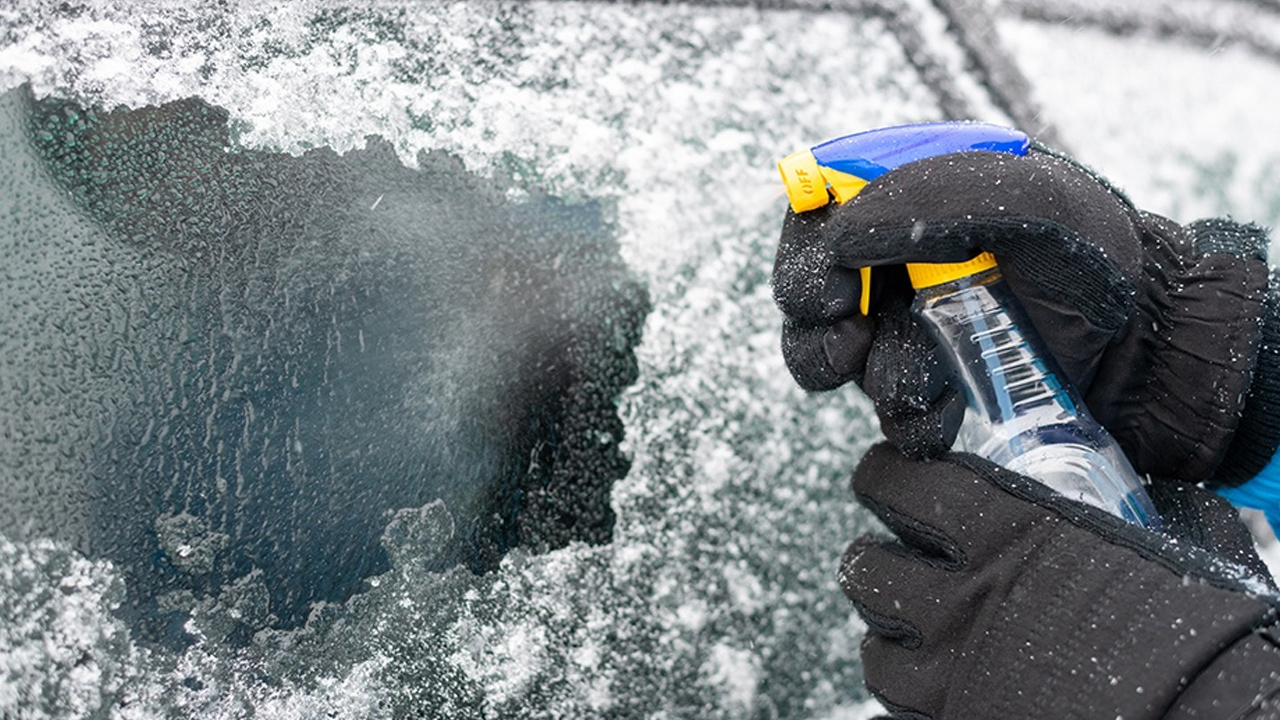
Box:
[1085,214,1280,484]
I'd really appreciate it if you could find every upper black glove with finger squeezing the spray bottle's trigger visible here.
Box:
[773,147,1280,484]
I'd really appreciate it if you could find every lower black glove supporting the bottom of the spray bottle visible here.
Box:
[840,443,1280,720]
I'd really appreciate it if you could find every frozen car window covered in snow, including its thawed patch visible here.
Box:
[0,1,1280,717]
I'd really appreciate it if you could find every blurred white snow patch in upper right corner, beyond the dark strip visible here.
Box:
[1000,3,1280,227]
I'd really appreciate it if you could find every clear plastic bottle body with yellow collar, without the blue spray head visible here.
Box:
[908,252,1160,528]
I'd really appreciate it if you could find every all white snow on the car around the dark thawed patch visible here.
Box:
[0,3,1280,720]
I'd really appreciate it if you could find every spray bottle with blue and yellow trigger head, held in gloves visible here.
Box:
[778,123,1160,528]
